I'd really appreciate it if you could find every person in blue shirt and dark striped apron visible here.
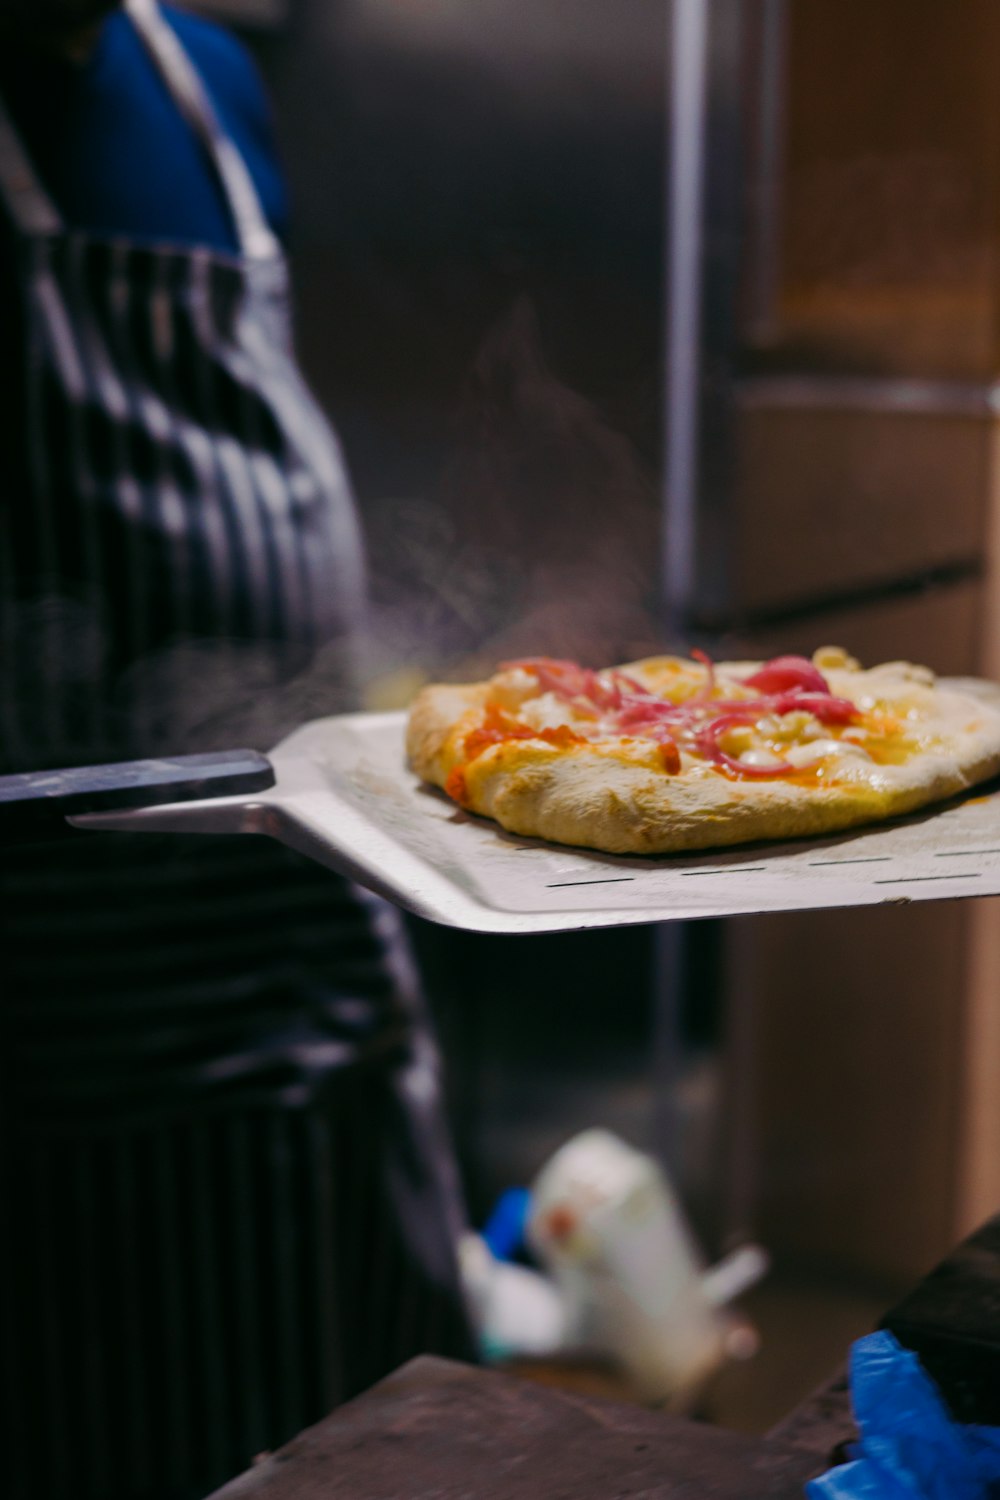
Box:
[0,0,472,1500]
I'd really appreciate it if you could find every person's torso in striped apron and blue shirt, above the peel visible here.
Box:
[0,0,363,768]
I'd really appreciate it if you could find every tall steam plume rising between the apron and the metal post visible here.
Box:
[365,299,660,678]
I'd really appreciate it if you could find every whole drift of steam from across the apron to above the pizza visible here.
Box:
[4,300,660,770]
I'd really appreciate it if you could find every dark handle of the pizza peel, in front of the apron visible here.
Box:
[0,750,274,842]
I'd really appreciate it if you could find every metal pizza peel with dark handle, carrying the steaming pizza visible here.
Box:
[0,684,1000,933]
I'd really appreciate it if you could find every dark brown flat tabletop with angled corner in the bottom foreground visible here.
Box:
[206,1358,826,1500]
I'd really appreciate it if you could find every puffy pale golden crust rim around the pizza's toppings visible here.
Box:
[406,653,1000,855]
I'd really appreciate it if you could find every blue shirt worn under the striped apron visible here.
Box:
[0,6,286,252]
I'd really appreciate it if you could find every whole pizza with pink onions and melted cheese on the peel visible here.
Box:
[406,647,1000,855]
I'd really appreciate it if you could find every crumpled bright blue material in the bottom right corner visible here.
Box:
[807,1332,1000,1500]
